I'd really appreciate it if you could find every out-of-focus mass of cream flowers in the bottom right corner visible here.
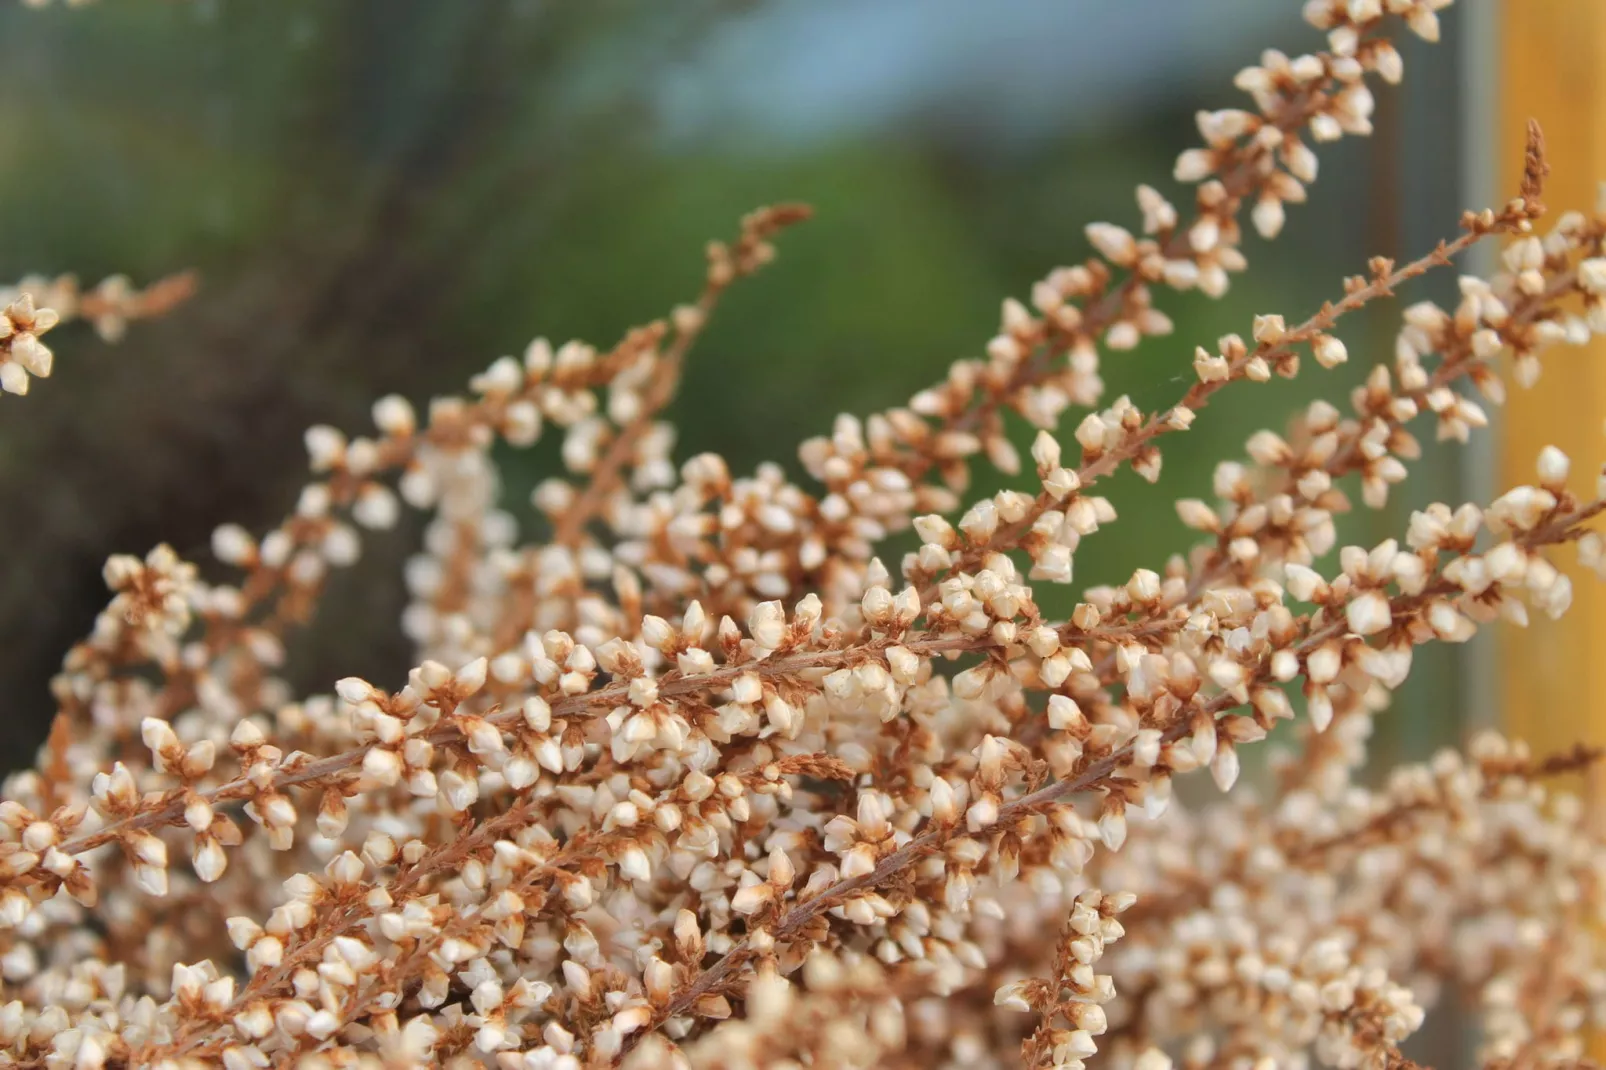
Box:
[1072,732,1606,1067]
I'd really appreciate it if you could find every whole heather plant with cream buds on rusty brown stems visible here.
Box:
[15,0,1606,1070]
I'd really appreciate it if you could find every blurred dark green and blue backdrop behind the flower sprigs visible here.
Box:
[0,0,1468,768]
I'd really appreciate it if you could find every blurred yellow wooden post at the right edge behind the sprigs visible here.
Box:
[1496,0,1606,784]
